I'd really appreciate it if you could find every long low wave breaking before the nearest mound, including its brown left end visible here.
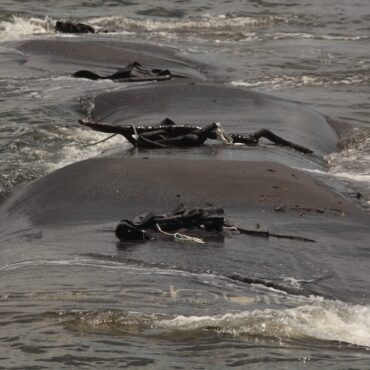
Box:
[65,297,370,347]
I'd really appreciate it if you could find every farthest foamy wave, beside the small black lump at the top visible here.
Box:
[0,14,370,43]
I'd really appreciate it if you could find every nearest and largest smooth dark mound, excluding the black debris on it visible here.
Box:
[0,158,370,302]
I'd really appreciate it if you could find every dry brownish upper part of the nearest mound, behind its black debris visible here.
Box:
[0,157,368,225]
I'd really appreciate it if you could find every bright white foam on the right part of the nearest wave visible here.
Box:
[158,297,370,347]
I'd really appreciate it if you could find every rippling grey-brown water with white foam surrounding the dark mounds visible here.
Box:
[0,0,370,369]
